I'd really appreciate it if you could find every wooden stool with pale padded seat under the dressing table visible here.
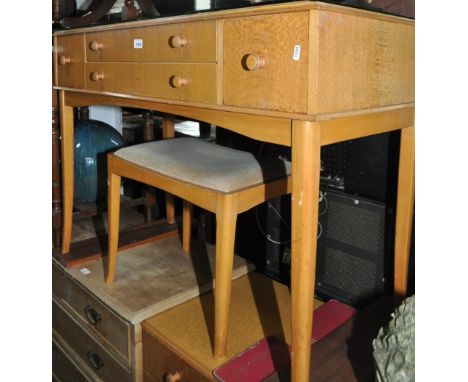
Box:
[106,138,291,358]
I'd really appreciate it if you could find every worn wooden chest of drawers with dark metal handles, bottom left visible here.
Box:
[52,236,252,382]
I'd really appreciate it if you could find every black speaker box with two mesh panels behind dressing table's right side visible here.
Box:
[316,191,393,306]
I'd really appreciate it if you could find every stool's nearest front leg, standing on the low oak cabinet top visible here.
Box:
[214,195,237,359]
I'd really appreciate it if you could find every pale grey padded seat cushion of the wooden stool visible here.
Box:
[115,138,291,193]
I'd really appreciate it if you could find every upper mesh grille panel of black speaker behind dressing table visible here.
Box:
[327,201,382,254]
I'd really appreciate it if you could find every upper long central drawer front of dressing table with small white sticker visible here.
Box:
[86,21,216,62]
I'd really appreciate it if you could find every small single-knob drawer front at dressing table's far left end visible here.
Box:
[55,34,84,88]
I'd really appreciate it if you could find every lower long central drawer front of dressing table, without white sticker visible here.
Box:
[86,63,216,104]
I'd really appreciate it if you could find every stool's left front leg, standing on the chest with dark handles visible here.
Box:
[106,157,121,284]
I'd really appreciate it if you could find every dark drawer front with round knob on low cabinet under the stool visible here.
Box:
[143,330,213,382]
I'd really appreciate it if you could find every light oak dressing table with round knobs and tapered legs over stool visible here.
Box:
[54,1,414,381]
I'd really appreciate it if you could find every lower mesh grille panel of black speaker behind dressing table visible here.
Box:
[323,247,377,297]
